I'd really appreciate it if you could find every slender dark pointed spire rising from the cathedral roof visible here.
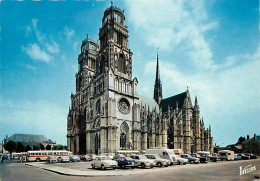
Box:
[153,52,162,104]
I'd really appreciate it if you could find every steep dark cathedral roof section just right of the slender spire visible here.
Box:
[160,92,186,112]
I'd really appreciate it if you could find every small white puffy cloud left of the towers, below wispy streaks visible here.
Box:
[22,43,53,63]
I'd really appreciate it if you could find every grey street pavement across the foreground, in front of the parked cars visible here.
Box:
[0,159,260,181]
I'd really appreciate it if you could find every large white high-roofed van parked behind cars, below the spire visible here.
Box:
[146,148,177,165]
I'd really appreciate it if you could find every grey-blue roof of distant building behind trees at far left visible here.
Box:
[8,134,49,145]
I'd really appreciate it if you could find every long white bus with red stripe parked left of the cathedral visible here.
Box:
[26,150,72,162]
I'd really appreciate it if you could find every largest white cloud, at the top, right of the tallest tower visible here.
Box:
[125,0,218,70]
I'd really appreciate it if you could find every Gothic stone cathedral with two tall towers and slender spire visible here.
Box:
[67,4,213,154]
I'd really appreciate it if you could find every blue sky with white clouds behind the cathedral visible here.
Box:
[0,0,260,146]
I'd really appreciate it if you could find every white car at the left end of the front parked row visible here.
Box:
[91,156,117,170]
